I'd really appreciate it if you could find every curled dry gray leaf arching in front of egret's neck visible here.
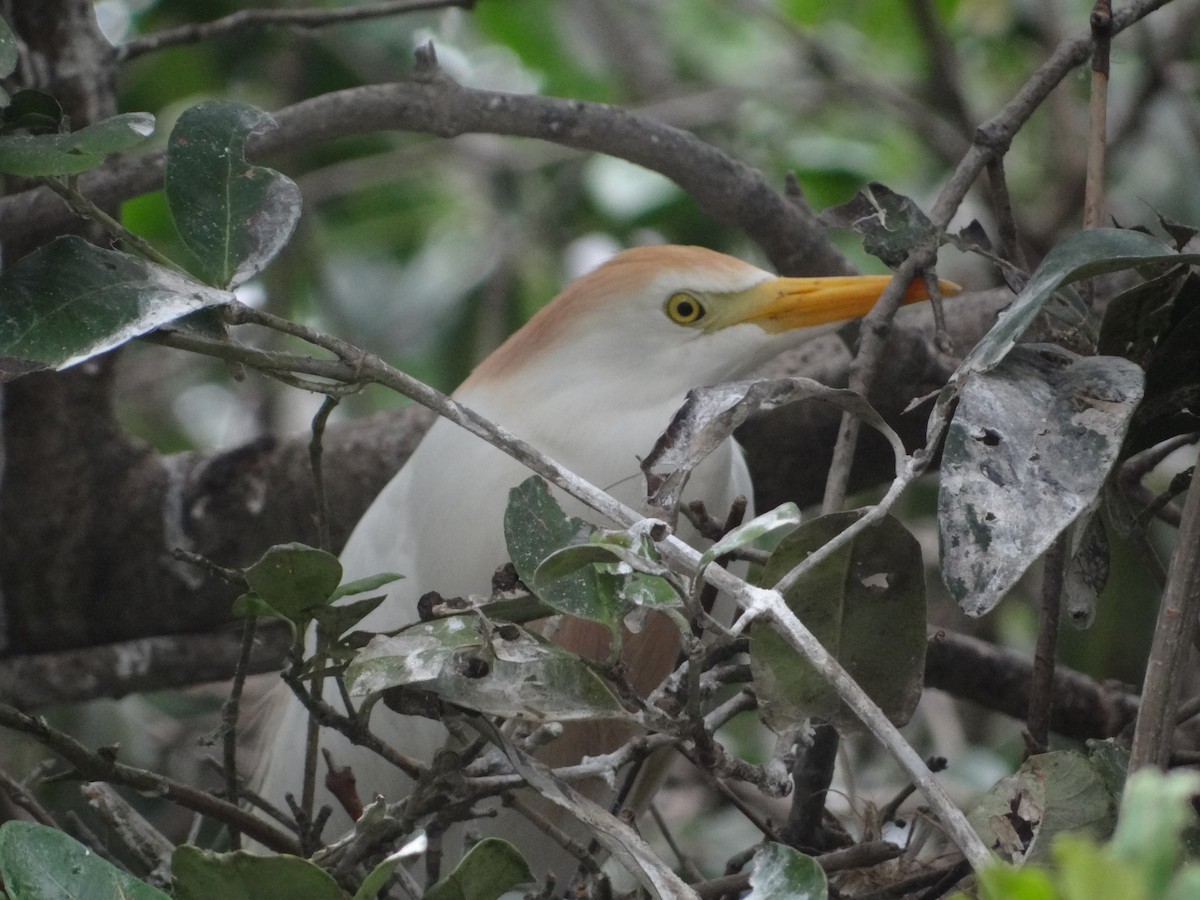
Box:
[642,378,906,521]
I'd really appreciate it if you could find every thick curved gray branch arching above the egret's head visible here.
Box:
[0,47,852,275]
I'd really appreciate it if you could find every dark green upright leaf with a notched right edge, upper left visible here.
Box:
[166,102,300,287]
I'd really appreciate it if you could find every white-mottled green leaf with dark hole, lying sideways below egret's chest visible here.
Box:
[346,616,626,721]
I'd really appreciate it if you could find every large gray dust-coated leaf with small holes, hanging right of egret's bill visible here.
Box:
[937,344,1144,616]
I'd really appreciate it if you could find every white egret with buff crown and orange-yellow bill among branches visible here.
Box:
[257,246,949,878]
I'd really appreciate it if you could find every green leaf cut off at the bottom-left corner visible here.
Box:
[0,822,169,900]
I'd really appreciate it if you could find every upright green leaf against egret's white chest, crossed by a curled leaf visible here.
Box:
[504,475,624,630]
